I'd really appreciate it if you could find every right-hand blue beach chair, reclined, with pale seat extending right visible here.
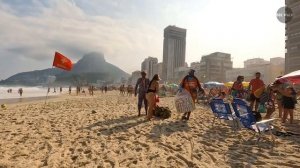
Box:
[232,98,275,143]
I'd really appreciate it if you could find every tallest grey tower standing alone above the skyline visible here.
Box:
[162,26,186,81]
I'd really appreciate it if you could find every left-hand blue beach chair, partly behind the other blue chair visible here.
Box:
[209,99,238,128]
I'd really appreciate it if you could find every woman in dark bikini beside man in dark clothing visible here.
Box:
[146,74,160,121]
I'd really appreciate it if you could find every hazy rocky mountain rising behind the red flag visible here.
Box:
[0,52,129,86]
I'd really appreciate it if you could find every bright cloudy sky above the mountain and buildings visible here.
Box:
[0,0,285,79]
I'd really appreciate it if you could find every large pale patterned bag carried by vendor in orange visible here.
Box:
[175,89,195,113]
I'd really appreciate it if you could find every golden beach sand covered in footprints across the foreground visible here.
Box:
[0,92,300,168]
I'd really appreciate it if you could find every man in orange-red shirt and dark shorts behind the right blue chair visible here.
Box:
[248,72,265,111]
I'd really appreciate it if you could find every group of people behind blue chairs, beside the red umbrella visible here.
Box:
[225,72,297,123]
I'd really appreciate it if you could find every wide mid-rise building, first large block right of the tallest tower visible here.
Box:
[200,52,232,82]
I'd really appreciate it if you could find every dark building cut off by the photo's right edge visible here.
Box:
[285,0,300,73]
